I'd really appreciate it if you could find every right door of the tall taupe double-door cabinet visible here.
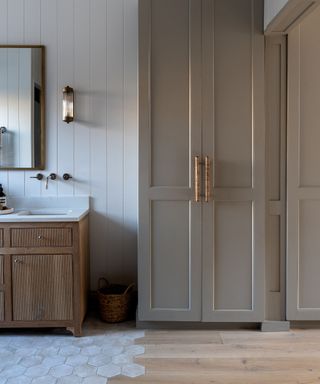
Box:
[202,0,265,322]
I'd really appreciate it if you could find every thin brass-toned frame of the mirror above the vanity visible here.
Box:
[0,45,46,171]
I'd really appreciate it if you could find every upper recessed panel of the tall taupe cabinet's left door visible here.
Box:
[150,0,190,186]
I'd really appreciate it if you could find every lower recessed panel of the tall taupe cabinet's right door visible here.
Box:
[214,202,252,310]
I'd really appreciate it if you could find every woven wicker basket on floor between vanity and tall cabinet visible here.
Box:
[98,278,134,323]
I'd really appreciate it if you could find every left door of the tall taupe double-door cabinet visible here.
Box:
[139,0,201,321]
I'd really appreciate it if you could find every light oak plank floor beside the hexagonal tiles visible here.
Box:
[108,330,320,384]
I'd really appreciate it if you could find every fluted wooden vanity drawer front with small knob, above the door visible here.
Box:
[10,227,72,248]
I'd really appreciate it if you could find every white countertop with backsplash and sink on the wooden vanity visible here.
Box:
[0,196,89,223]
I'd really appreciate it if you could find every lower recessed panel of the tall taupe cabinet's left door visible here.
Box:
[151,201,191,309]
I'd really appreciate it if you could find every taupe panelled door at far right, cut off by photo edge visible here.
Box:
[287,9,320,320]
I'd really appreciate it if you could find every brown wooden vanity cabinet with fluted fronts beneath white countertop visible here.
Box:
[0,217,89,336]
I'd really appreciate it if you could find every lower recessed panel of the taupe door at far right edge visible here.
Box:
[298,200,320,308]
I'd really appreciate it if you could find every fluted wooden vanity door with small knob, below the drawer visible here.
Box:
[11,255,73,321]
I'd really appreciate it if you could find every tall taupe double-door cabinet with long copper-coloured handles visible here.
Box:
[138,0,265,322]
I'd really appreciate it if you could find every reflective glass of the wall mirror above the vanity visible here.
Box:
[0,46,44,169]
